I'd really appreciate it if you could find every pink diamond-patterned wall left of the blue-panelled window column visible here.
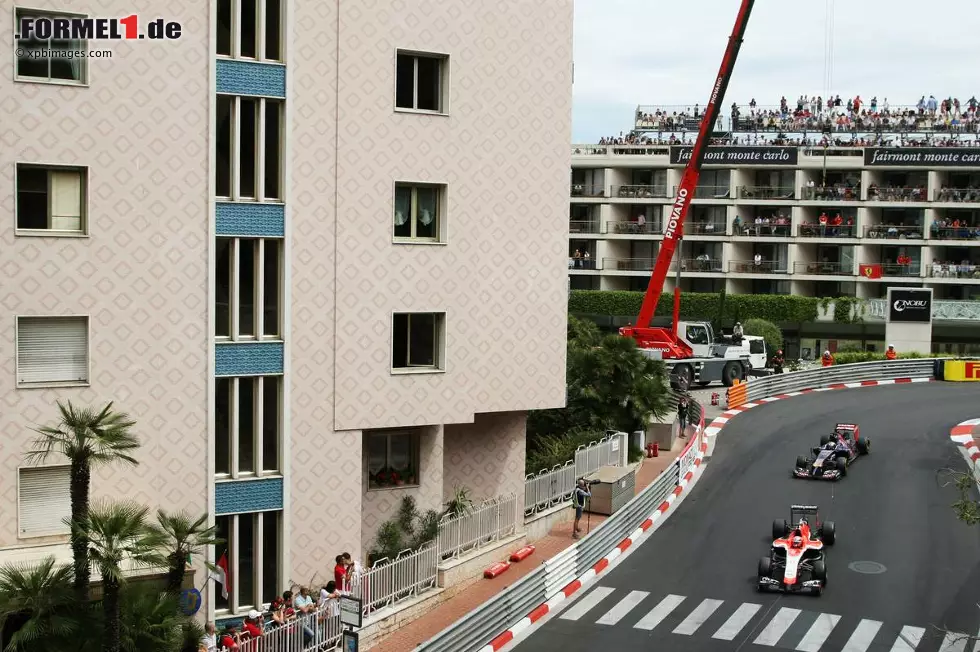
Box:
[0,0,210,547]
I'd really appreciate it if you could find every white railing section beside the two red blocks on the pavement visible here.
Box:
[438,493,518,559]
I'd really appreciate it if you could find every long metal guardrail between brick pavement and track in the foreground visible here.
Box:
[416,407,704,652]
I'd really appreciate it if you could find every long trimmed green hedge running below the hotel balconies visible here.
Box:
[568,290,820,324]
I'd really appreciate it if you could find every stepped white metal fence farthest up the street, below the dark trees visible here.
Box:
[524,432,628,517]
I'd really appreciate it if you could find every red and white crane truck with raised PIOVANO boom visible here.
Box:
[619,0,768,387]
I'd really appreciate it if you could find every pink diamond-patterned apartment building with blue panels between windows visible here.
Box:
[0,0,572,620]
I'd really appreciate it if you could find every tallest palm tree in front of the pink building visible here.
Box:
[27,401,139,601]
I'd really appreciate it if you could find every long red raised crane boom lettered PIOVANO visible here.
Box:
[631,0,755,328]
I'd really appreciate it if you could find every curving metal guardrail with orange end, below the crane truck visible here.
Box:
[726,358,943,408]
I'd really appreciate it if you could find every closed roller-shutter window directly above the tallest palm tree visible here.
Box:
[17,317,88,387]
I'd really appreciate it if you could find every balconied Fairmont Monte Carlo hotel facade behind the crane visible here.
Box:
[569,143,980,299]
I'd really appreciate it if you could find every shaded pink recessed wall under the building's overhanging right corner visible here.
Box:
[442,412,526,505]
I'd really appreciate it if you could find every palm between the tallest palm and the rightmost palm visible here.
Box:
[73,502,167,652]
